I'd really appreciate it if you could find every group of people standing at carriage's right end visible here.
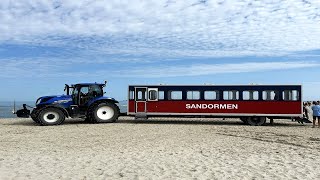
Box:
[303,101,320,128]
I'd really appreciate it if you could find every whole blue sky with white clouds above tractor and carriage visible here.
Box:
[0,0,320,101]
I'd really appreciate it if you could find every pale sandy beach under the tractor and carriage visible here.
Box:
[0,117,320,179]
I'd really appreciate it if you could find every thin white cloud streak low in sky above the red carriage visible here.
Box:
[112,61,320,78]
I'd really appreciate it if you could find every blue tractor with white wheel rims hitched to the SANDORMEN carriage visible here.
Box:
[15,82,120,125]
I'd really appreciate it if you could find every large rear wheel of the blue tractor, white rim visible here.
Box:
[88,102,119,123]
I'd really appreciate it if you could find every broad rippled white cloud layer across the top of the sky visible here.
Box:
[0,0,320,57]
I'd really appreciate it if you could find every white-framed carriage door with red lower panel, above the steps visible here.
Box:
[135,87,148,113]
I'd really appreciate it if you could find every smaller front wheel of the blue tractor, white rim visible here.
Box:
[37,108,65,126]
